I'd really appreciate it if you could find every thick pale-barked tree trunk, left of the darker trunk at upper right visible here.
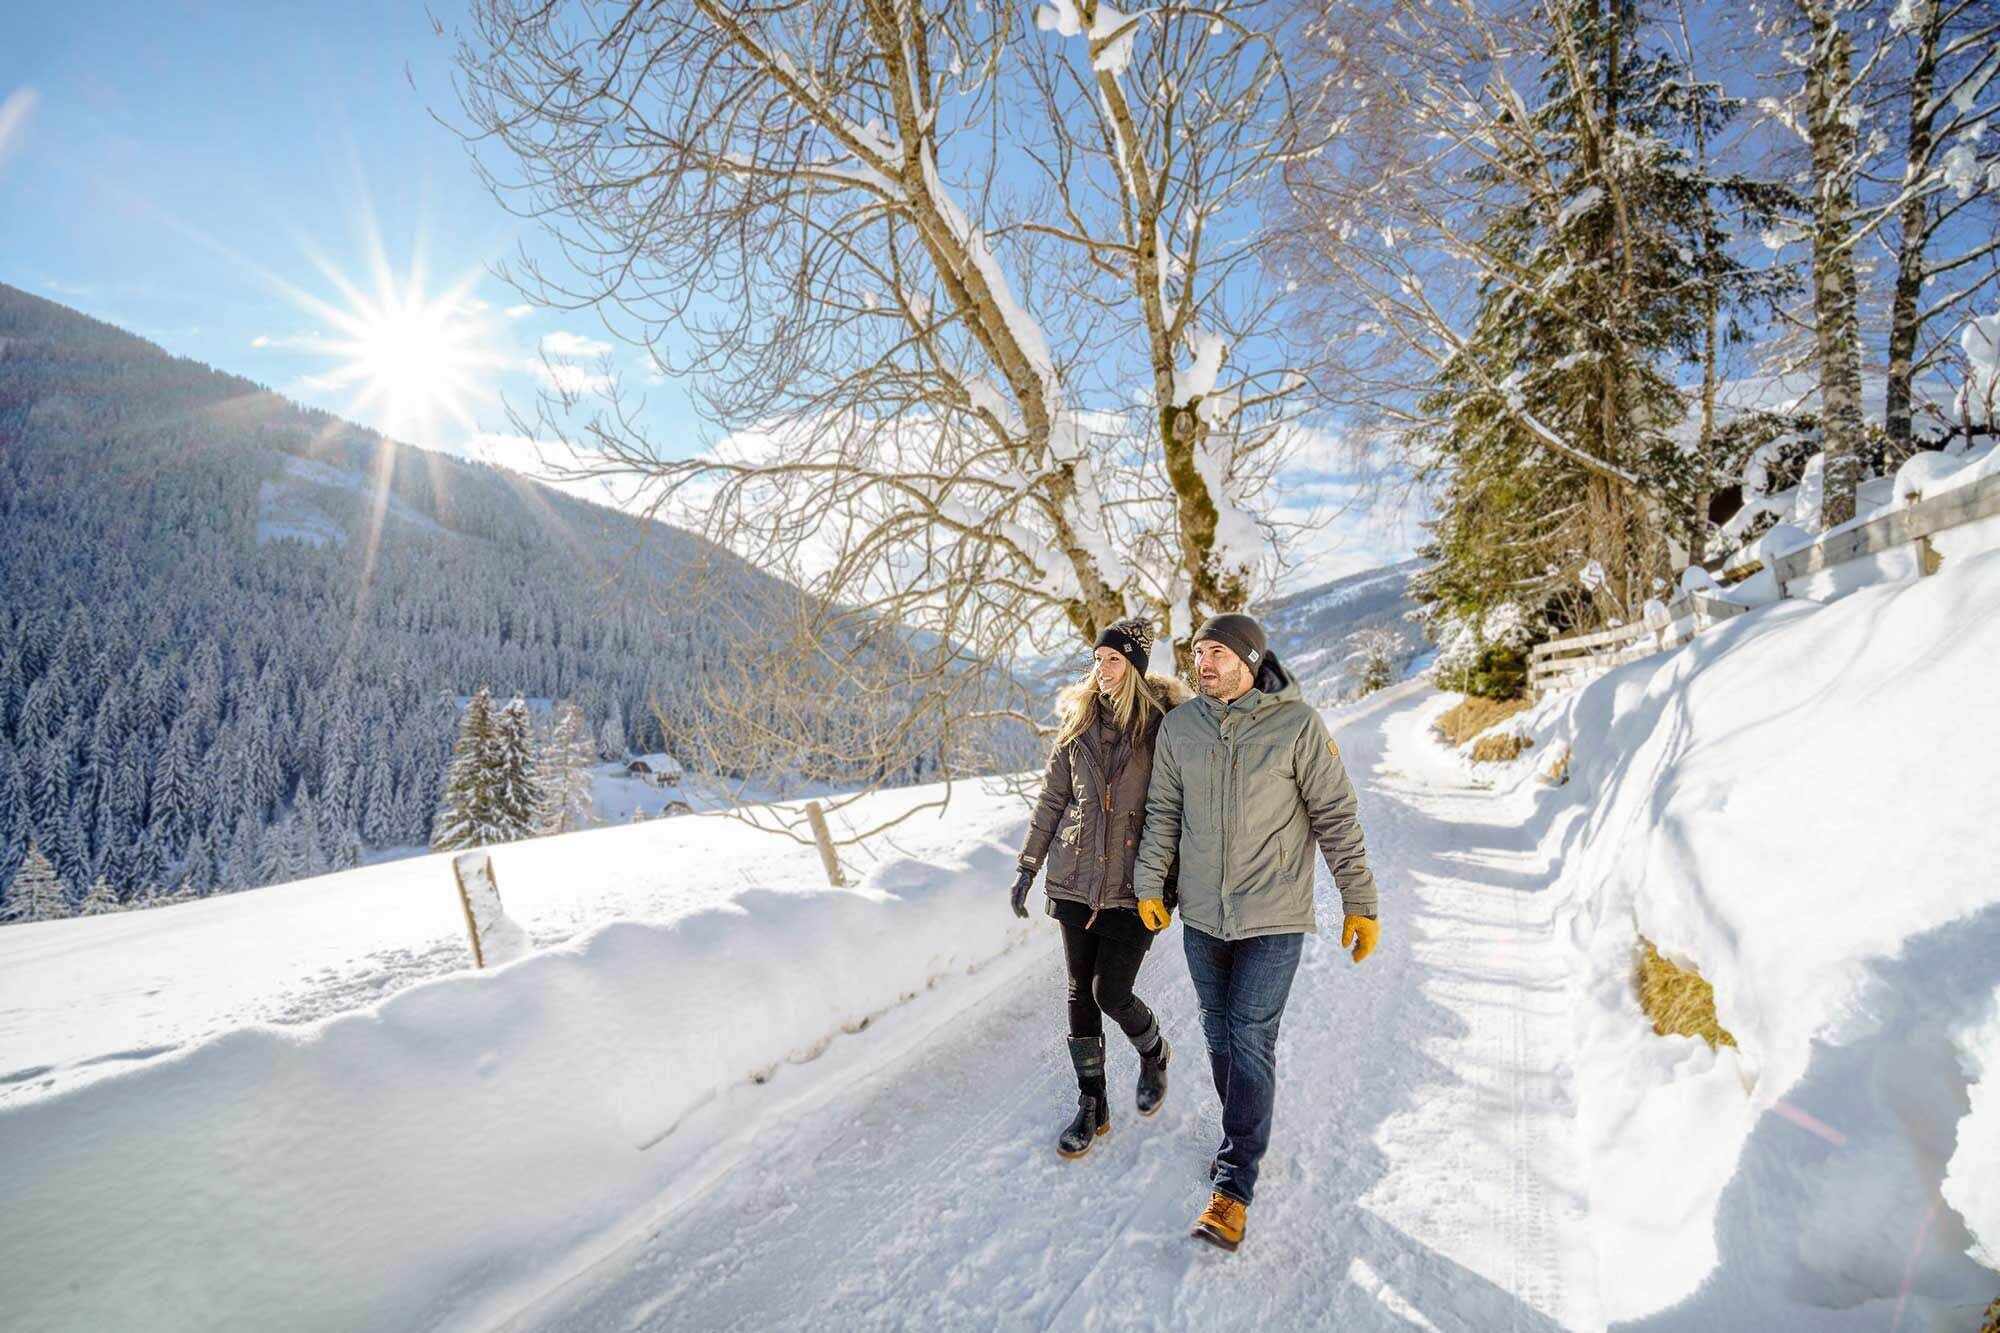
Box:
[1806,0,1862,528]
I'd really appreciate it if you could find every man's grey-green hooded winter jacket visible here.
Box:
[1132,658,1376,939]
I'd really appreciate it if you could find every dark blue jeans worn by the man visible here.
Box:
[1180,923,1306,1203]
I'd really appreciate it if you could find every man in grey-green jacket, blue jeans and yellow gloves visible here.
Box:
[1132,614,1378,1251]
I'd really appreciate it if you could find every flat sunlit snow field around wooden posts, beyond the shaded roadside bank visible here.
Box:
[0,783,1022,1107]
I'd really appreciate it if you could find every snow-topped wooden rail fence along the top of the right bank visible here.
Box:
[1528,474,2000,691]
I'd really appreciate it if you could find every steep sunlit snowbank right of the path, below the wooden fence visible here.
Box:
[1534,552,2000,1329]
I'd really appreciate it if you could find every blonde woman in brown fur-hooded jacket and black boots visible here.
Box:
[1014,618,1190,1157]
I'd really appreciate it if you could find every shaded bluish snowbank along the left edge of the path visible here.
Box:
[0,784,1046,1329]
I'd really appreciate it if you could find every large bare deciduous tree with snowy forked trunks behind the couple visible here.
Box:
[460,0,1328,824]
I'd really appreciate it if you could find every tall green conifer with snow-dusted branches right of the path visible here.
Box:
[1416,0,1740,622]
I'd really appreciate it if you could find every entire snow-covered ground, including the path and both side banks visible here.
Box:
[0,552,2000,1333]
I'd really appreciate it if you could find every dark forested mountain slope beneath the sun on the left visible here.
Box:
[0,284,812,901]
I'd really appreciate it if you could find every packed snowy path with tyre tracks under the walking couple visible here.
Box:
[484,687,1600,1329]
